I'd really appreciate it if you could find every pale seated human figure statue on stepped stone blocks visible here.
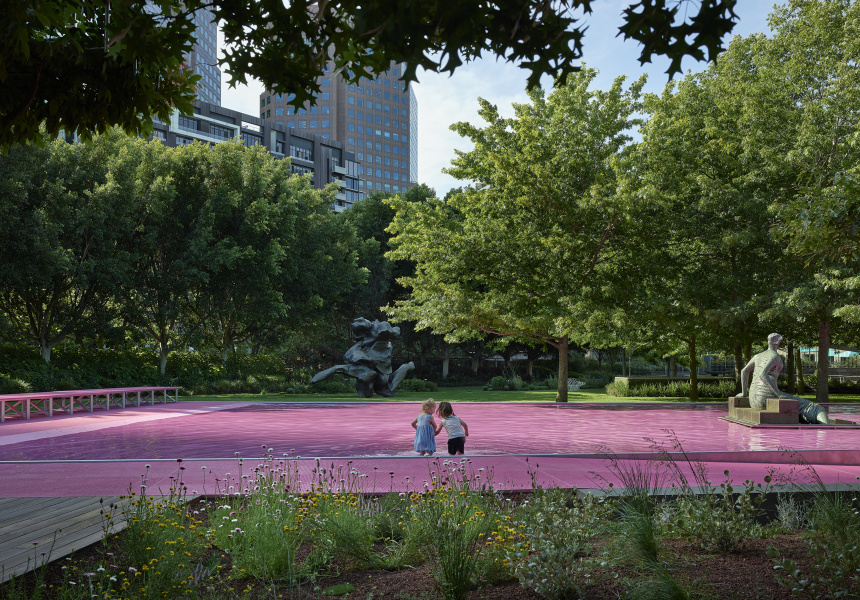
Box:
[737,333,828,425]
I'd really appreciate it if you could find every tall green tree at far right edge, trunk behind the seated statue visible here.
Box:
[729,0,860,401]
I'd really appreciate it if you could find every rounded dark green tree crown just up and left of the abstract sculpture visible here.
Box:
[189,141,366,361]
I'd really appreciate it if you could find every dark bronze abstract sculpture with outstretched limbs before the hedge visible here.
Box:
[311,317,415,398]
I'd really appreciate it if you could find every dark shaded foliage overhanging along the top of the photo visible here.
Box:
[0,0,737,146]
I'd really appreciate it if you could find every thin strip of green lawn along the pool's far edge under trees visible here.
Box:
[181,387,860,402]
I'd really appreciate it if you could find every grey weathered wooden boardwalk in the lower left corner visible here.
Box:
[0,496,125,583]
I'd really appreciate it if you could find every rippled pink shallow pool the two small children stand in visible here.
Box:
[0,402,860,464]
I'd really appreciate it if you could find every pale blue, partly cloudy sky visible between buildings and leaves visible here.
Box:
[219,0,773,198]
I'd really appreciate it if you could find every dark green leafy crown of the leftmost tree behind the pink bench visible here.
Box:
[0,132,146,362]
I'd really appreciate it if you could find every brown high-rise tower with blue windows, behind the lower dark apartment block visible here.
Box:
[260,62,418,193]
